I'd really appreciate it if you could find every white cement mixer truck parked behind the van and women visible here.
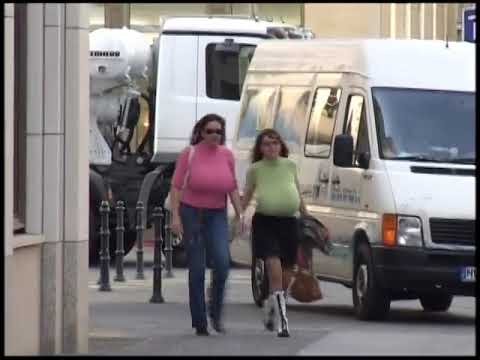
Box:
[90,17,307,264]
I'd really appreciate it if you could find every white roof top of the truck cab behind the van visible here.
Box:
[162,16,295,35]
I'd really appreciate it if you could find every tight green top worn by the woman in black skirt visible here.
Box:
[246,157,300,216]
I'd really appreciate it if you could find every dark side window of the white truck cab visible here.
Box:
[205,43,256,100]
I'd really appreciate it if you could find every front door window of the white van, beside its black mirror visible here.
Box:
[343,95,370,166]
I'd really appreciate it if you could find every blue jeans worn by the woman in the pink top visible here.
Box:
[180,203,230,327]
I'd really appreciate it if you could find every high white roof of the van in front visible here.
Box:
[249,39,475,91]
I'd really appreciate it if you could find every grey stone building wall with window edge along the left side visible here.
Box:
[3,3,89,355]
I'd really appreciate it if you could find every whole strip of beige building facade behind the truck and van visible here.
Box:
[90,3,474,41]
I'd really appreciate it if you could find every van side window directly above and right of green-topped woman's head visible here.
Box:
[273,87,310,150]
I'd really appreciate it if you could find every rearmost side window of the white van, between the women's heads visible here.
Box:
[238,87,277,141]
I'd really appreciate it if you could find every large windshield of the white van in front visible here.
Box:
[372,87,476,164]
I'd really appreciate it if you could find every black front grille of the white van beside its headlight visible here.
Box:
[430,218,475,246]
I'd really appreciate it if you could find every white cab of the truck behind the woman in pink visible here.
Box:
[152,17,301,163]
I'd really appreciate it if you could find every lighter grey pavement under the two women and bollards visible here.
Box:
[88,261,325,355]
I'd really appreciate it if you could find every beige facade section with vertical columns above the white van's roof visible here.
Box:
[305,3,470,41]
